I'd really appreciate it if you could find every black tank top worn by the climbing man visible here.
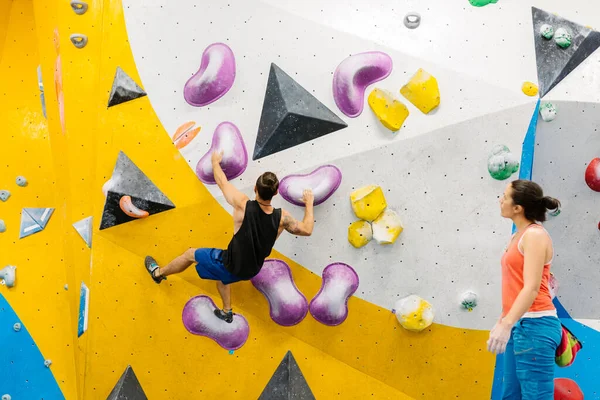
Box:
[223,200,281,279]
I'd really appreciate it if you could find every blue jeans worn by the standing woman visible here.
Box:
[502,317,562,400]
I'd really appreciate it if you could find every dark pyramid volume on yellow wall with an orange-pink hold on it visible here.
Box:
[100,151,175,230]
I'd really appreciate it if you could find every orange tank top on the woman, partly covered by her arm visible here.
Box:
[502,224,555,317]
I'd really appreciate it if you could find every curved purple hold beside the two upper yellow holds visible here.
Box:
[333,51,393,118]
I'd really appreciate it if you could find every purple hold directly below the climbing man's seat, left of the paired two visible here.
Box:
[251,260,308,326]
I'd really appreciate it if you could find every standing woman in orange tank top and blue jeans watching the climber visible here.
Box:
[487,180,562,400]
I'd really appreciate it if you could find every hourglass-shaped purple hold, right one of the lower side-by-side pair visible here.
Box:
[308,263,359,326]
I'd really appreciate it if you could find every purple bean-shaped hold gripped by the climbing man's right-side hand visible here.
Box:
[279,165,342,206]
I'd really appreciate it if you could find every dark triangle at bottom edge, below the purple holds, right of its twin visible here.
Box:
[258,350,315,400]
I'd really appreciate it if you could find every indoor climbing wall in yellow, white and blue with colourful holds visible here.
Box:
[0,0,600,399]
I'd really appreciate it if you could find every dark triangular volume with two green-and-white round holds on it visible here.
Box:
[531,7,600,97]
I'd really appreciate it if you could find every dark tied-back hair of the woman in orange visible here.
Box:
[511,179,560,222]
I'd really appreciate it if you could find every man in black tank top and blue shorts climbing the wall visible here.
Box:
[145,152,314,323]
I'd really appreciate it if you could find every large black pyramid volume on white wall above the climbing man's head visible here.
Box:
[252,63,348,160]
